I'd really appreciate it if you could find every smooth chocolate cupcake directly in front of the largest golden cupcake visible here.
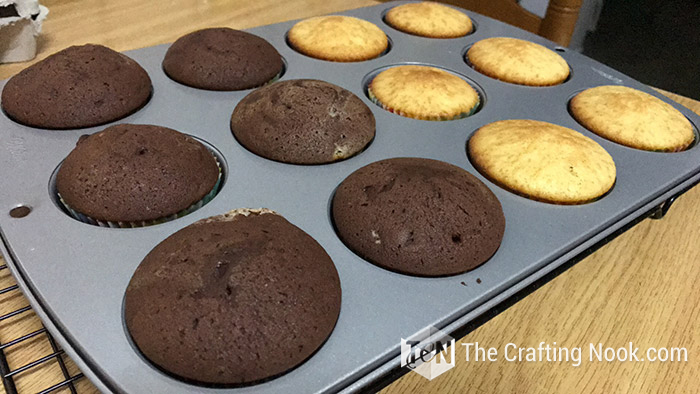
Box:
[332,158,505,276]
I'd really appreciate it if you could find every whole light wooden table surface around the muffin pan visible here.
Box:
[0,0,700,393]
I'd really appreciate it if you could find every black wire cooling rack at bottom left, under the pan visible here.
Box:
[0,256,92,394]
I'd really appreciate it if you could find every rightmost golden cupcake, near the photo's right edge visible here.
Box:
[570,85,695,152]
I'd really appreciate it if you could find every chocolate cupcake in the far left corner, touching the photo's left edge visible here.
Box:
[2,44,152,129]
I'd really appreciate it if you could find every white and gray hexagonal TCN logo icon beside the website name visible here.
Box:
[401,326,455,380]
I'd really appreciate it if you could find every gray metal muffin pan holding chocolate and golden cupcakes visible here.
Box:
[0,2,700,393]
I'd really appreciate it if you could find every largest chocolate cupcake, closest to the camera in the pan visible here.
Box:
[124,209,341,386]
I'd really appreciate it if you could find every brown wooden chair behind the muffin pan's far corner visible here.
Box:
[441,0,583,46]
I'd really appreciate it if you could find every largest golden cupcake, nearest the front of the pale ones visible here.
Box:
[469,119,616,204]
